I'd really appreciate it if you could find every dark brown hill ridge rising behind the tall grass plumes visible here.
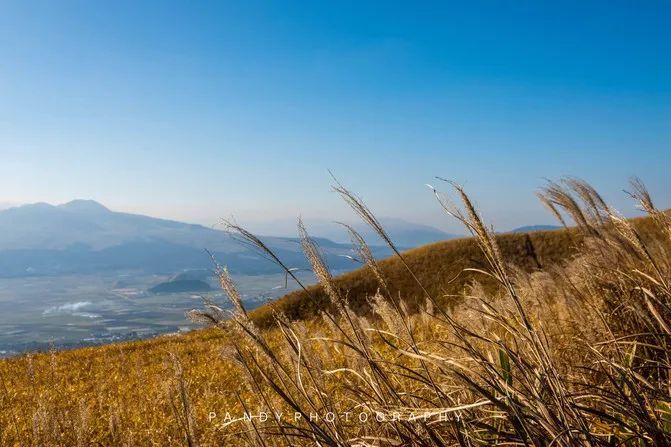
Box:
[251,217,668,326]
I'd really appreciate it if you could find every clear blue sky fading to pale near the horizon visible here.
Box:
[0,0,671,234]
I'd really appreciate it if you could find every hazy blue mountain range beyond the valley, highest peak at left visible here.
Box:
[0,200,453,277]
